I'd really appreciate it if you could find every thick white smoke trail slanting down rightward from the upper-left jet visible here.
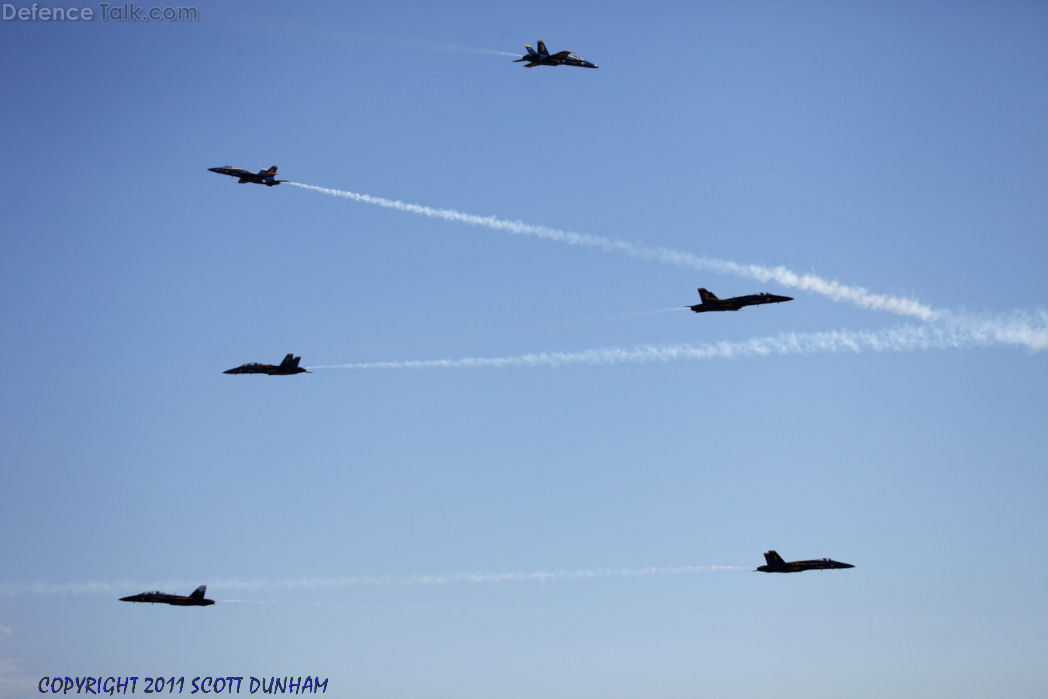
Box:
[287,181,937,321]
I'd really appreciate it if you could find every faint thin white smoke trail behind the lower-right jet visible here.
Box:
[0,565,750,604]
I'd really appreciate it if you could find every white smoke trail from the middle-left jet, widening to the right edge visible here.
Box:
[309,310,1048,370]
